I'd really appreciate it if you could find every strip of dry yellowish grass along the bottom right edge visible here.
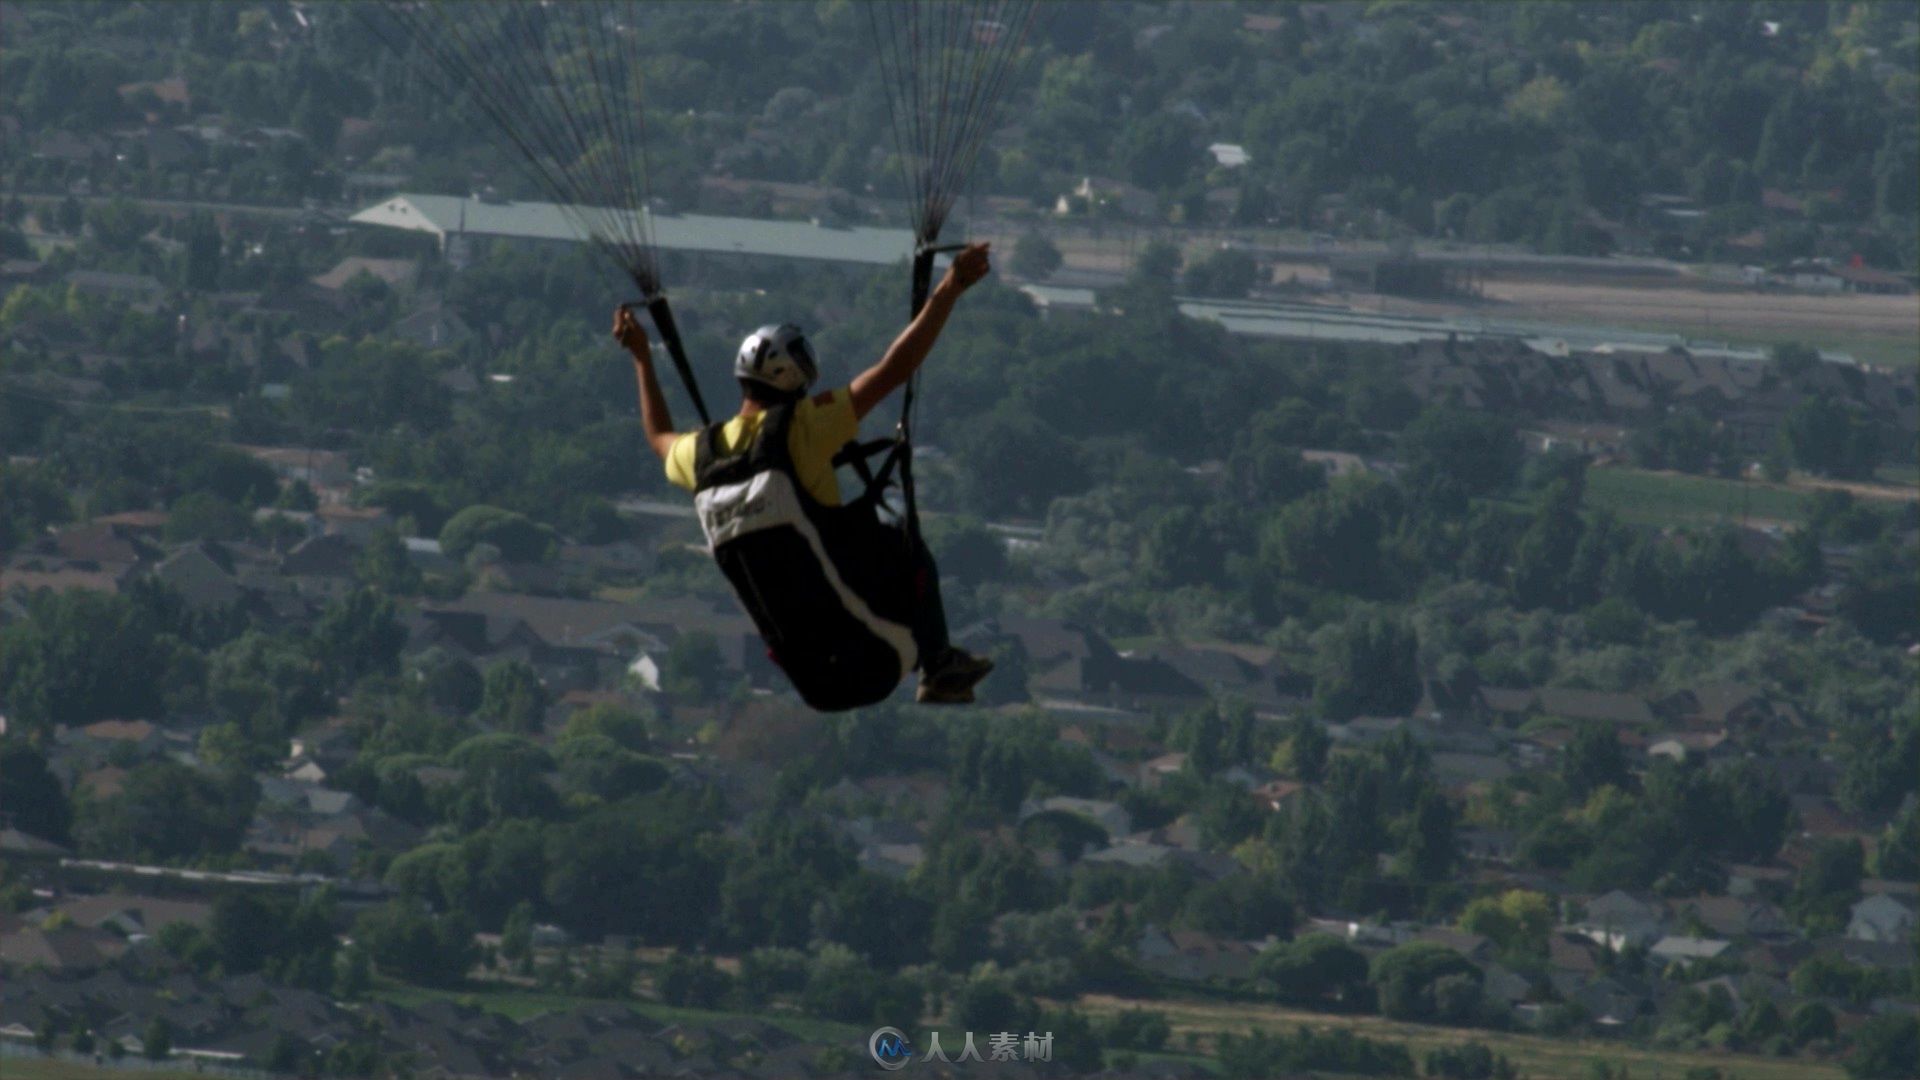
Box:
[1079,995,1845,1080]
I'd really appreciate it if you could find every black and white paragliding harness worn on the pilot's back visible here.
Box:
[693,404,920,711]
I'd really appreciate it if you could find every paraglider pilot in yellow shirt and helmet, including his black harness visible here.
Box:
[612,244,993,709]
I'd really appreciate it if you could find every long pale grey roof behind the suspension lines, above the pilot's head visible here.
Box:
[351,194,914,265]
